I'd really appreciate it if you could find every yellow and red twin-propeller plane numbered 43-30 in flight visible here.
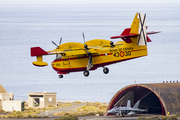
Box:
[31,13,158,78]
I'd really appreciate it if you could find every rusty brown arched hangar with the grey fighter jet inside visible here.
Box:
[107,83,180,115]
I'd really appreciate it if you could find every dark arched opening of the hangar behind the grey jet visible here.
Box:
[108,87,165,114]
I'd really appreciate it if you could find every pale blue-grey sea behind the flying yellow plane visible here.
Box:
[0,3,180,103]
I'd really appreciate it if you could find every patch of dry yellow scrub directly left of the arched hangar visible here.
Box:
[54,102,108,116]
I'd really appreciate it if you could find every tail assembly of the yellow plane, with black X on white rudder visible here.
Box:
[111,13,159,46]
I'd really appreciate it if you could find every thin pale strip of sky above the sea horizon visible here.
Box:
[0,0,180,4]
